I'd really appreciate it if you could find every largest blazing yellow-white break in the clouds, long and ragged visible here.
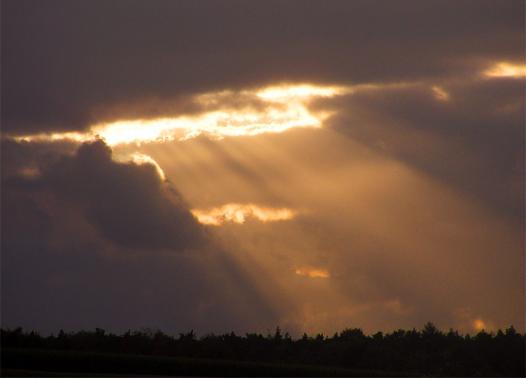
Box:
[15,84,347,146]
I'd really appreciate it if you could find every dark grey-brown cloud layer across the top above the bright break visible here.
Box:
[2,0,524,133]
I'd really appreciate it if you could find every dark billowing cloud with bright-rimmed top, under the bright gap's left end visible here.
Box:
[4,141,205,251]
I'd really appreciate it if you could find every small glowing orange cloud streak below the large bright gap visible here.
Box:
[192,203,296,226]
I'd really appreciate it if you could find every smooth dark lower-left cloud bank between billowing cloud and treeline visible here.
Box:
[2,192,275,333]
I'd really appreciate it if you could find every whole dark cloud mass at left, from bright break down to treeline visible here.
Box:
[1,141,276,333]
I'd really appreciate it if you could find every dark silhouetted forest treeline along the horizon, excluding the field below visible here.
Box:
[1,323,526,376]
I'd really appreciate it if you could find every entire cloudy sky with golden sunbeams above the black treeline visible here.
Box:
[1,0,526,335]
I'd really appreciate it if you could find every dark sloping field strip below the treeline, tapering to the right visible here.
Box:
[2,348,405,377]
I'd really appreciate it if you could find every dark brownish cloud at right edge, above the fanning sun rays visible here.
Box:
[328,79,525,222]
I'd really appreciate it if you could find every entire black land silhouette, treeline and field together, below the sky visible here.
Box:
[0,323,526,377]
